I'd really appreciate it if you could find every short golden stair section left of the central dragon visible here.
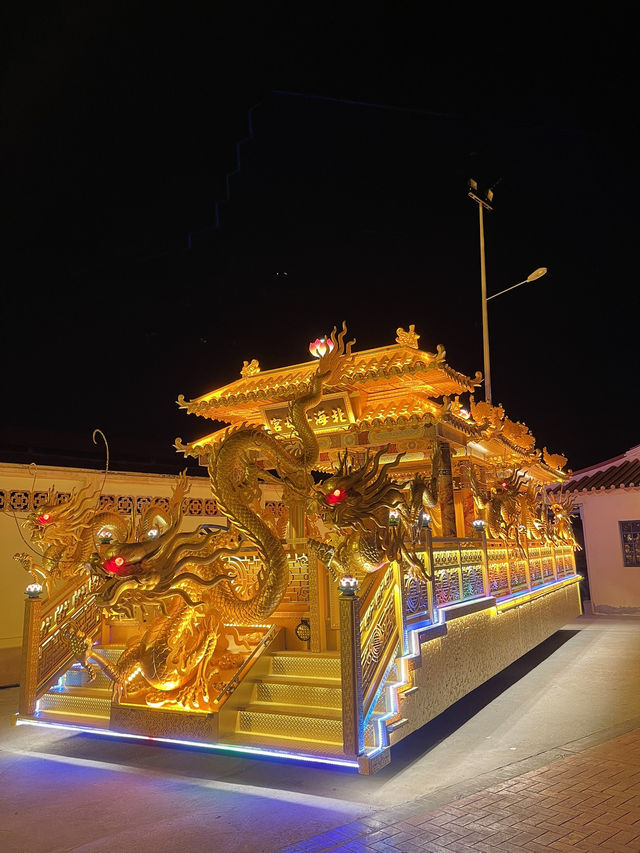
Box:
[35,646,124,729]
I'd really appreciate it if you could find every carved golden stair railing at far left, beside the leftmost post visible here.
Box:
[19,575,104,716]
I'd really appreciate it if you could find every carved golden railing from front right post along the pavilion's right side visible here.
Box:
[340,532,575,755]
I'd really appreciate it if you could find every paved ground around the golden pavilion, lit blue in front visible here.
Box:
[0,617,640,853]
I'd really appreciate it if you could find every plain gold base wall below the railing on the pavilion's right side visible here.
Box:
[390,583,582,745]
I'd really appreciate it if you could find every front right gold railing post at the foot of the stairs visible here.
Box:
[340,587,364,756]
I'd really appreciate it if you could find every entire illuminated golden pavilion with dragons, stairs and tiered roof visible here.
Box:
[12,324,580,773]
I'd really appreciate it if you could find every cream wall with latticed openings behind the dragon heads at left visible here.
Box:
[0,463,226,686]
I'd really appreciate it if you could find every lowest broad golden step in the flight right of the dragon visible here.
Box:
[236,706,342,744]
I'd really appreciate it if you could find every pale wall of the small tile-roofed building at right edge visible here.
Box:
[576,488,640,613]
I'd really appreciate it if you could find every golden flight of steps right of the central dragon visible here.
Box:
[221,651,343,755]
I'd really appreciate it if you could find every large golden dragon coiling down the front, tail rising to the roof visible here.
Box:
[60,324,354,709]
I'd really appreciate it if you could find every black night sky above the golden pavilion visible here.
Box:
[0,2,640,473]
